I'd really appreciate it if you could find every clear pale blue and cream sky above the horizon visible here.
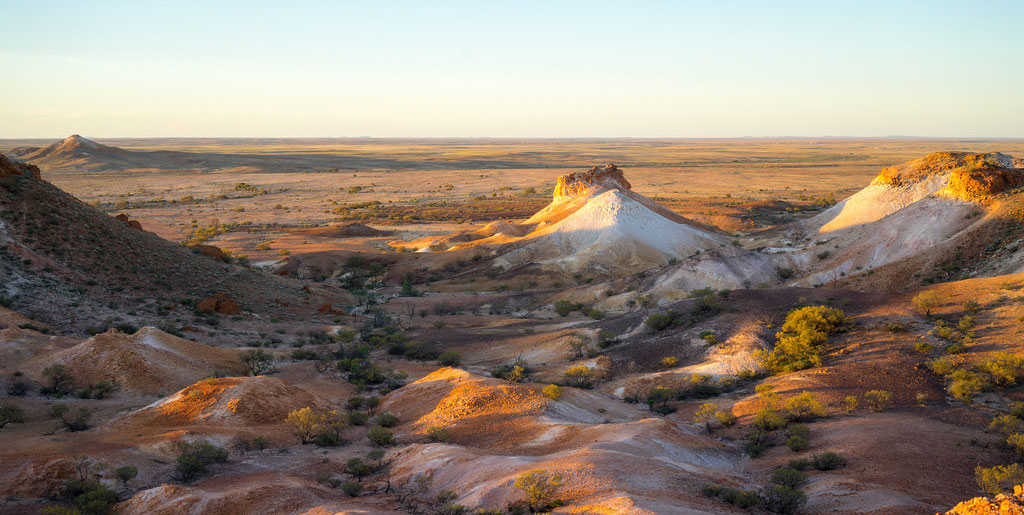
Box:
[0,0,1024,138]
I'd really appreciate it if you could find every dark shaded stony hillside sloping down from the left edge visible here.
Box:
[0,150,333,332]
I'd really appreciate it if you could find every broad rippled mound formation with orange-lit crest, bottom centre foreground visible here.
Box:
[382,369,739,514]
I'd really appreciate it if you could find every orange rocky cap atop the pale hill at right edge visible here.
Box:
[872,152,1024,201]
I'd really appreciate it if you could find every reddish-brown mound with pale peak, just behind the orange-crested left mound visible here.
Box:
[37,328,244,395]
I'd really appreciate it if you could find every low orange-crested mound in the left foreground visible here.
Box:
[122,376,317,426]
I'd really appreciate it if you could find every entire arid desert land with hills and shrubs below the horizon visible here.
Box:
[0,135,1024,514]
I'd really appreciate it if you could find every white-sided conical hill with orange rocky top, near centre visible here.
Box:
[405,165,727,272]
